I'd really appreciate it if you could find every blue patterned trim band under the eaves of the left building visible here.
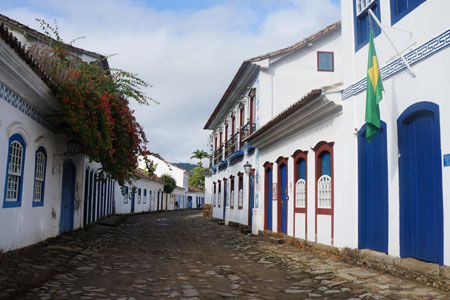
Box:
[0,82,56,132]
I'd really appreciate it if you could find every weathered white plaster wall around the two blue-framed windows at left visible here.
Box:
[0,85,74,251]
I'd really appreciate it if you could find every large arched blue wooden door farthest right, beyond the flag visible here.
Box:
[397,102,444,264]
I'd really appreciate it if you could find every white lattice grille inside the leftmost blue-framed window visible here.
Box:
[6,141,23,201]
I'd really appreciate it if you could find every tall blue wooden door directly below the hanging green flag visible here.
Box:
[358,121,389,253]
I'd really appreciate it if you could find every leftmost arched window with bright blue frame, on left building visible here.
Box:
[3,134,26,208]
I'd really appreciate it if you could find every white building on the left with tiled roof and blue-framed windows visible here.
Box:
[0,15,114,251]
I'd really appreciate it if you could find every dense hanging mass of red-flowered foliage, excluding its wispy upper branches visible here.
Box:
[57,64,149,183]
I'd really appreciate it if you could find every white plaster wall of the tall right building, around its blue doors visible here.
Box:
[342,0,450,265]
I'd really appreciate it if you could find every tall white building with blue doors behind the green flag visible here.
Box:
[342,0,450,265]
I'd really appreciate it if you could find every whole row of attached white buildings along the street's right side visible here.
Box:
[205,0,450,265]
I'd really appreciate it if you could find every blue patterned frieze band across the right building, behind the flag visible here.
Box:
[342,29,450,100]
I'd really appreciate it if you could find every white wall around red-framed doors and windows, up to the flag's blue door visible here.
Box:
[253,94,357,248]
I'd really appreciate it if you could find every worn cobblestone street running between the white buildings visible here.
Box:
[0,211,450,300]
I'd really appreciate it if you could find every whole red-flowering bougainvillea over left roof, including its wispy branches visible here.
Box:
[30,20,154,184]
